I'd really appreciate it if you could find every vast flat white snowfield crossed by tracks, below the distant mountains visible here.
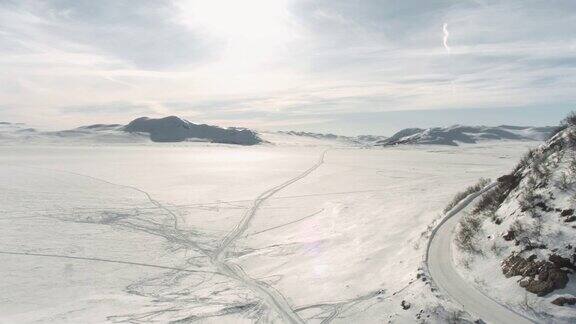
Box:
[0,138,537,323]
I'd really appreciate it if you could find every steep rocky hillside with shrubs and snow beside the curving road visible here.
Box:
[455,118,576,322]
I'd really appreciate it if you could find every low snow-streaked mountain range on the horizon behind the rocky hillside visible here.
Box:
[375,125,554,146]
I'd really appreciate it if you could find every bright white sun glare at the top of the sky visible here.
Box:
[178,0,297,87]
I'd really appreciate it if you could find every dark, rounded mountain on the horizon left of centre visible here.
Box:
[121,116,262,145]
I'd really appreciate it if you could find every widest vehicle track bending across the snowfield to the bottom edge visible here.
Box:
[212,150,328,323]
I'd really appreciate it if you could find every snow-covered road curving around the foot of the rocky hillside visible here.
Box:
[426,184,535,324]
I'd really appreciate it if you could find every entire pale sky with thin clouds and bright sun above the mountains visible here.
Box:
[0,0,576,134]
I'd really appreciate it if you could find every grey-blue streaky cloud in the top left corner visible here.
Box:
[0,0,216,69]
